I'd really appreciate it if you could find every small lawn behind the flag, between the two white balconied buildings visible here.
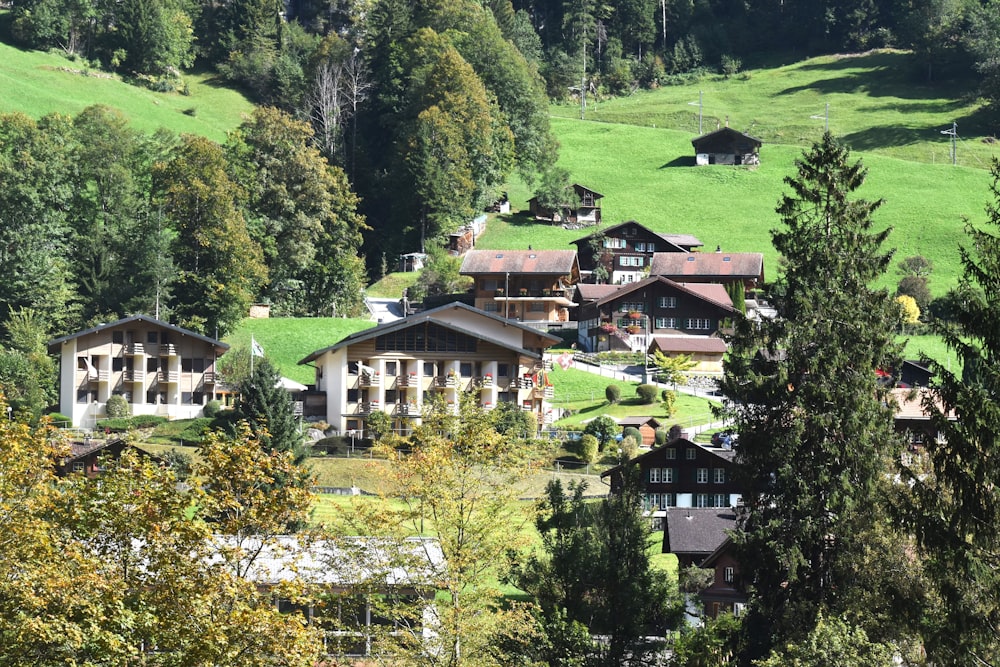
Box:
[225,317,375,384]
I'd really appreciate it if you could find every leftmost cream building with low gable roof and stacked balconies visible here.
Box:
[48,315,229,428]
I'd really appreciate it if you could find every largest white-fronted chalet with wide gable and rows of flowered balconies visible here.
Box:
[299,303,561,435]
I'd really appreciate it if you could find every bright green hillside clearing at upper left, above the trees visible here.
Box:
[0,35,253,142]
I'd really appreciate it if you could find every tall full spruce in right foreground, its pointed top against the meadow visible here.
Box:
[722,133,899,658]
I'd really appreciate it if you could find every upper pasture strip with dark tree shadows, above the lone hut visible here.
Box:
[551,51,997,167]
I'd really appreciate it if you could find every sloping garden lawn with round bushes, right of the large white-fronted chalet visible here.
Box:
[550,366,717,428]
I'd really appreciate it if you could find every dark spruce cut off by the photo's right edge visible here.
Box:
[904,158,1000,665]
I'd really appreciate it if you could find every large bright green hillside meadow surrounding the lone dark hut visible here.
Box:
[478,52,1000,296]
